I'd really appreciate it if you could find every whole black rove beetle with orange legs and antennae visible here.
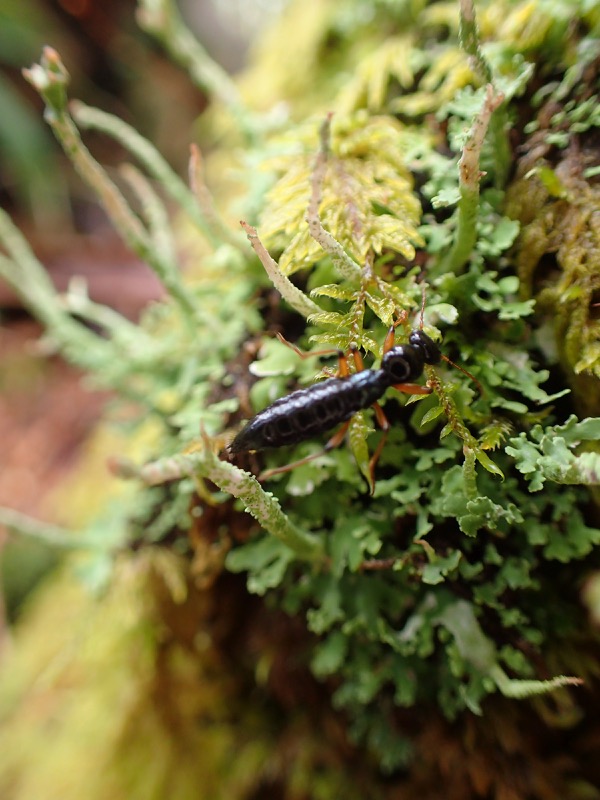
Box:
[228,310,454,489]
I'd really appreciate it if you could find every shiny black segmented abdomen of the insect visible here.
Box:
[229,370,387,453]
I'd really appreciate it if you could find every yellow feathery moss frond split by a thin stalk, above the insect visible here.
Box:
[260,114,422,275]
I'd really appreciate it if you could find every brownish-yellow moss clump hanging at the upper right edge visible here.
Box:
[507,39,600,414]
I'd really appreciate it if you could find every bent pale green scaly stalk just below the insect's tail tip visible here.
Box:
[139,450,325,561]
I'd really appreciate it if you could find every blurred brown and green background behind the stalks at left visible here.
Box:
[0,0,284,627]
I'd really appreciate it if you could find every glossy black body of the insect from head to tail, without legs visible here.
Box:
[229,330,441,453]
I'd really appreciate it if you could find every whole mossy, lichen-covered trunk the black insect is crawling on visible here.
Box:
[0,0,600,800]
